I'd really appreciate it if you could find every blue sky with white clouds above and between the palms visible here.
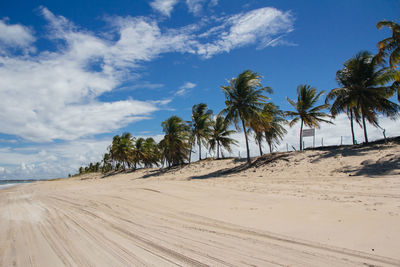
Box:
[0,0,400,179]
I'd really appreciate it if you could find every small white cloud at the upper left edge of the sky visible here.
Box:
[0,20,35,53]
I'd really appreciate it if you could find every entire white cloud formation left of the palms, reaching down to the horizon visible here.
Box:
[0,5,293,178]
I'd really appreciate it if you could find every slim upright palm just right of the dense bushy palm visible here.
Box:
[192,103,213,160]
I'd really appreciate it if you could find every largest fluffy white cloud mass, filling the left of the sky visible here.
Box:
[0,8,197,142]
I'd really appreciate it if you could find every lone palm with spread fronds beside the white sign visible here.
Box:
[286,84,332,150]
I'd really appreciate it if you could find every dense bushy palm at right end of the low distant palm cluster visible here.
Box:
[160,116,190,166]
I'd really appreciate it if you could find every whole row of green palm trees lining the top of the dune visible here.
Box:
[76,21,400,172]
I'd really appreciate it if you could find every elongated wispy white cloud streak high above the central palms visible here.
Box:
[198,7,294,58]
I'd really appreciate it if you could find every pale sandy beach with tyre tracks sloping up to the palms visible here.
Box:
[0,143,400,266]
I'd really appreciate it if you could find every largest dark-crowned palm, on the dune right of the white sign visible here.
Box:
[328,51,399,143]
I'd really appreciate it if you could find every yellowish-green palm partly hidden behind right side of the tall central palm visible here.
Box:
[263,102,287,153]
